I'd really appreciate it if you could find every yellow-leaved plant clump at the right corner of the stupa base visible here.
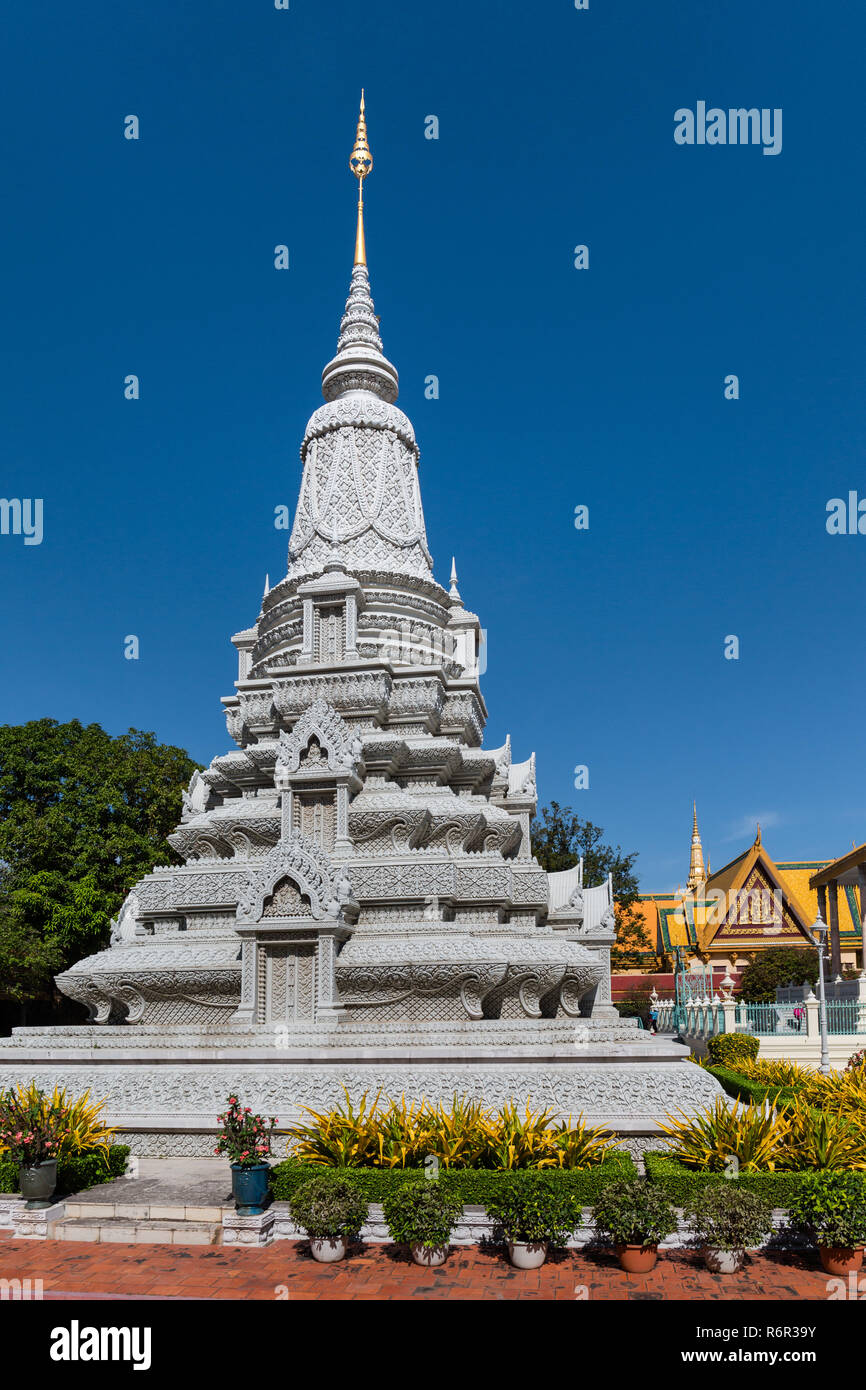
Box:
[659,1097,791,1173]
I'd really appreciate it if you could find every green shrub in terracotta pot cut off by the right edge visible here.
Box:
[788,1169,866,1276]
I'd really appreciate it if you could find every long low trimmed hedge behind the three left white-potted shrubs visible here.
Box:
[271,1150,637,1207]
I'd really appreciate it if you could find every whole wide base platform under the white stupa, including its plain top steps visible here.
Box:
[0,1019,723,1158]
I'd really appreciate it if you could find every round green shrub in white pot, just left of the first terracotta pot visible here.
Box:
[487,1170,581,1269]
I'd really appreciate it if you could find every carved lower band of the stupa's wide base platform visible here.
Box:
[0,1056,720,1154]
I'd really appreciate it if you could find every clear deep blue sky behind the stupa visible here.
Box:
[0,0,866,891]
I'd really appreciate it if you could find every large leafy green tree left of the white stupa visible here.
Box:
[0,719,197,999]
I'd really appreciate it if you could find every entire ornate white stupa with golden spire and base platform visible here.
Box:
[0,92,719,1155]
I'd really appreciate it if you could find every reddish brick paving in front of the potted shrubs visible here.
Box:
[0,1238,827,1301]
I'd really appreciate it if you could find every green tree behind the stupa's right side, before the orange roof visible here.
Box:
[531,801,656,969]
